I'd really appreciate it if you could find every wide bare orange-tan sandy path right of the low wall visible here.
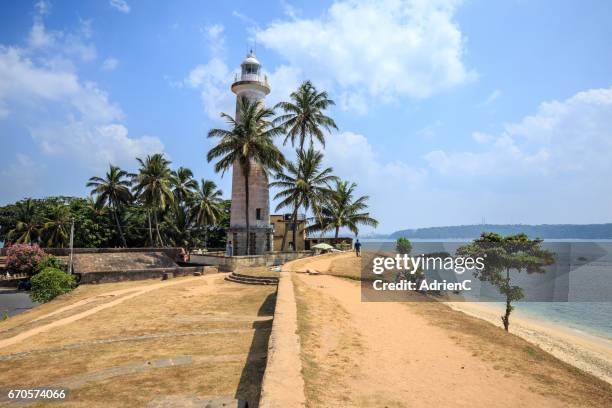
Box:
[294,270,567,408]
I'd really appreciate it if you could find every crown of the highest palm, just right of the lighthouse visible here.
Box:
[274,81,338,151]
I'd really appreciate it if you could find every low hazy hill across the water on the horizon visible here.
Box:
[389,224,612,239]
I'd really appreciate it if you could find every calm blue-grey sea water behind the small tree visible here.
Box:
[362,240,612,339]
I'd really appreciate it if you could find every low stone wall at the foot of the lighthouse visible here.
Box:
[191,251,313,272]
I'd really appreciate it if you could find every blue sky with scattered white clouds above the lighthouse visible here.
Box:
[0,0,612,232]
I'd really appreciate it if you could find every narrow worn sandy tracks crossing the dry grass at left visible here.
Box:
[0,277,203,349]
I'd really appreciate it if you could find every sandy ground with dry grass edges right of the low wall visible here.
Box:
[284,253,612,408]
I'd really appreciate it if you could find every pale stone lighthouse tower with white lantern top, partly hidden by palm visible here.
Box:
[227,50,273,255]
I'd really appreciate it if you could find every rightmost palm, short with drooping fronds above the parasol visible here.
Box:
[308,180,378,238]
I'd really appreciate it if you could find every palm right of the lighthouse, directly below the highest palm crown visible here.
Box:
[270,146,336,251]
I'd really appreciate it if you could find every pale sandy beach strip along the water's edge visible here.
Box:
[445,302,612,384]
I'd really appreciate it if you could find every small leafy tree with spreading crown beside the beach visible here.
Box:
[457,232,555,331]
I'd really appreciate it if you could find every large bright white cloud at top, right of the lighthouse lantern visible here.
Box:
[257,0,472,110]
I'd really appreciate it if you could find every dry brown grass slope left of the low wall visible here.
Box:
[0,275,276,407]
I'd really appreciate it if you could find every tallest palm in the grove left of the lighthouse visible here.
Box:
[134,153,174,245]
